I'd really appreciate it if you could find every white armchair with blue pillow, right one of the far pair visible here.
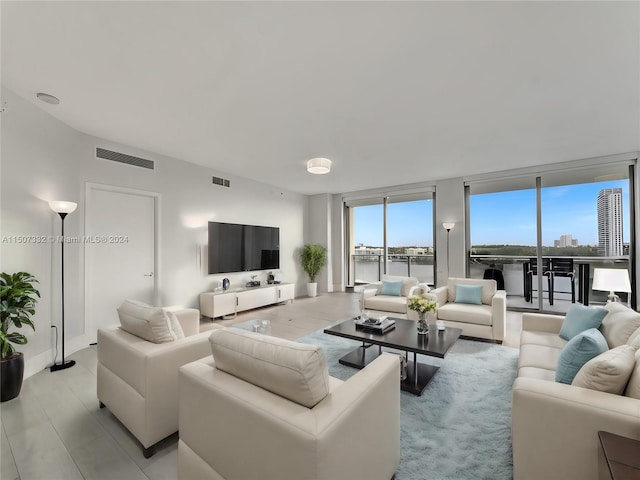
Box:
[428,278,507,342]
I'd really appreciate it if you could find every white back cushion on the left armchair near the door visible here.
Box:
[118,300,184,343]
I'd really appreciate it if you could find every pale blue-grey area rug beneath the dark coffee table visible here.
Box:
[236,322,518,480]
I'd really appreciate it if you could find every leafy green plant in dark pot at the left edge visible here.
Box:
[0,272,40,402]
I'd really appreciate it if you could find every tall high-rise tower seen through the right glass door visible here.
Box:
[598,188,622,257]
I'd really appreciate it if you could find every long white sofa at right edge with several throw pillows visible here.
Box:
[511,306,640,480]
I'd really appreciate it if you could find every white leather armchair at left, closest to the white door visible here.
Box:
[97,309,219,458]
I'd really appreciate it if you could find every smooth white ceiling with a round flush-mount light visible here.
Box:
[1,1,640,194]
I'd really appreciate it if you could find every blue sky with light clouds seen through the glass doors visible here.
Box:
[354,180,629,246]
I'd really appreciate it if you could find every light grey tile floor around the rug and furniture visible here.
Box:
[0,293,522,480]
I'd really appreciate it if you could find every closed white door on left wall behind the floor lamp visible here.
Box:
[85,185,157,343]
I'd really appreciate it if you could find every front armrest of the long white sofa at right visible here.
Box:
[511,378,640,480]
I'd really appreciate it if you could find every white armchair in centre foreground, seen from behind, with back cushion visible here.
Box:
[178,328,400,480]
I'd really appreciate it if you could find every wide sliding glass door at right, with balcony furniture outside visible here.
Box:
[467,163,635,313]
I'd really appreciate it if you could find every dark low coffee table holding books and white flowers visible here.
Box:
[324,318,462,395]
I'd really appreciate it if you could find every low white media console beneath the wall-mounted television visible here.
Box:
[200,283,295,318]
